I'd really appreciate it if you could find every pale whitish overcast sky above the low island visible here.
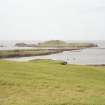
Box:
[0,0,105,40]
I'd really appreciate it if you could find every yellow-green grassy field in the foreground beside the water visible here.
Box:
[0,60,105,105]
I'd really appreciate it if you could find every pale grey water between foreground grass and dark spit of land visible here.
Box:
[1,41,105,65]
